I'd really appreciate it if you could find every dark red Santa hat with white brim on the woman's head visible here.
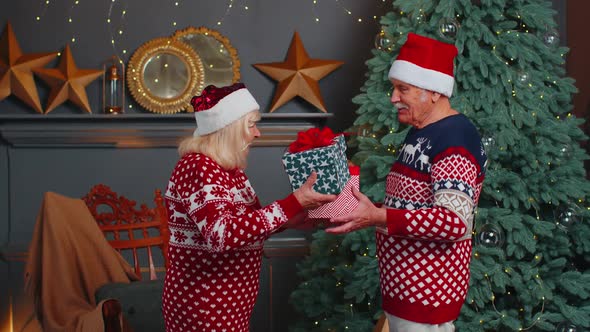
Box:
[191,83,260,136]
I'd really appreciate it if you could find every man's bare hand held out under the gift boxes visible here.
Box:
[326,187,387,234]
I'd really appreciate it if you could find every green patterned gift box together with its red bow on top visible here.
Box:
[282,127,350,194]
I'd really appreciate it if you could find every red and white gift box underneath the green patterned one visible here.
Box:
[308,166,360,221]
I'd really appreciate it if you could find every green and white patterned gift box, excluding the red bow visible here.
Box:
[282,135,350,194]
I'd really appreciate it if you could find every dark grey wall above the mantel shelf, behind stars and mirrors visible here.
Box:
[0,0,384,123]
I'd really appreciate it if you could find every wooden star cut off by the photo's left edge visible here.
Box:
[0,22,57,113]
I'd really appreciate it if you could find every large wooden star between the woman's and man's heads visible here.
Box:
[254,31,344,113]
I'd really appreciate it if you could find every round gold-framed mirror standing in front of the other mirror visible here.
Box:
[127,38,205,113]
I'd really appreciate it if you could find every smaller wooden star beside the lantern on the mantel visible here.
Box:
[33,44,103,114]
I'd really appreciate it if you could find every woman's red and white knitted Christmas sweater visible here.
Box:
[162,153,301,332]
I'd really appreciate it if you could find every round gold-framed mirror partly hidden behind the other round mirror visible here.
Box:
[172,27,240,93]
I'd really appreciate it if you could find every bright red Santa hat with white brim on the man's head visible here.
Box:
[388,32,458,97]
